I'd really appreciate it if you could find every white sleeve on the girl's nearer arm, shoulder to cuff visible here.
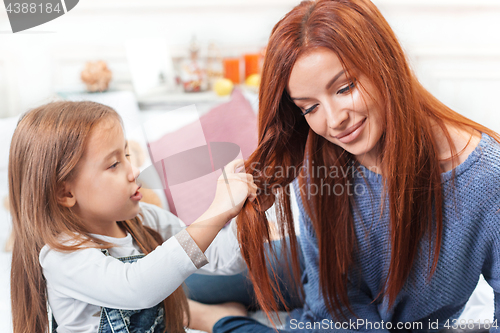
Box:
[39,233,197,310]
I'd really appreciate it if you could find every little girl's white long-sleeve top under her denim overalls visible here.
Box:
[39,203,246,333]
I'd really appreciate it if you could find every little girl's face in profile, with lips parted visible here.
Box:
[66,119,142,232]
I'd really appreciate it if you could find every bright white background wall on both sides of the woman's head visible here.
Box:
[0,0,500,131]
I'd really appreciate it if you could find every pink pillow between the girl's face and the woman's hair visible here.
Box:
[149,90,257,224]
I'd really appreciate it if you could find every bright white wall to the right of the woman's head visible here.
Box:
[376,0,500,132]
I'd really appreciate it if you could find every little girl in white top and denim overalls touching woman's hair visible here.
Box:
[9,102,256,333]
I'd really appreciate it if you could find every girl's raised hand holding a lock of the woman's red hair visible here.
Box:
[208,159,257,223]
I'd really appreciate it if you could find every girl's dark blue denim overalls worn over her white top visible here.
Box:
[52,250,165,333]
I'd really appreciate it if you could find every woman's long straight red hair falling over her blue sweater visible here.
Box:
[238,0,500,318]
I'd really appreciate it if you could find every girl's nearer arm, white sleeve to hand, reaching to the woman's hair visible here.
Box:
[39,160,256,309]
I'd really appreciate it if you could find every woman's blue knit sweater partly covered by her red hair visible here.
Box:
[288,133,500,332]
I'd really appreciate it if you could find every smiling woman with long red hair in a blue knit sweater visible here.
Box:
[187,0,500,332]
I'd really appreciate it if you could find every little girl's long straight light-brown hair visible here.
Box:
[8,102,189,333]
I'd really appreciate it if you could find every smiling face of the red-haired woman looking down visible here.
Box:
[288,48,384,166]
